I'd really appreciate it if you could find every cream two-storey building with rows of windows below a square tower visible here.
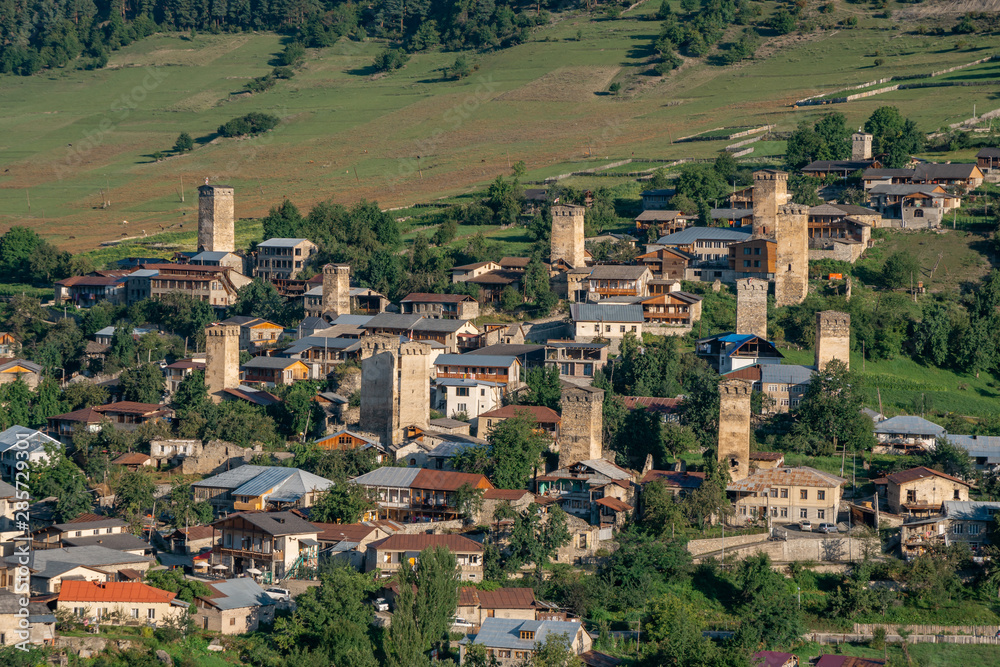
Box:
[726,466,847,524]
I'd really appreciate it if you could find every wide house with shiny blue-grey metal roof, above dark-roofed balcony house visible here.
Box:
[191,465,333,514]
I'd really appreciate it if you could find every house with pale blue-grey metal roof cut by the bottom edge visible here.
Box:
[460,617,592,667]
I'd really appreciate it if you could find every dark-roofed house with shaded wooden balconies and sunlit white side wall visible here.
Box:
[212,512,319,584]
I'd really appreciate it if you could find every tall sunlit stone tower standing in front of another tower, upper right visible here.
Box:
[774,204,809,307]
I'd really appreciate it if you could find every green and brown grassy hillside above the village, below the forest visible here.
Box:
[0,0,996,249]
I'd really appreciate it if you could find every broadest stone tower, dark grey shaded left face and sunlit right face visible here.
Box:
[361,336,430,446]
